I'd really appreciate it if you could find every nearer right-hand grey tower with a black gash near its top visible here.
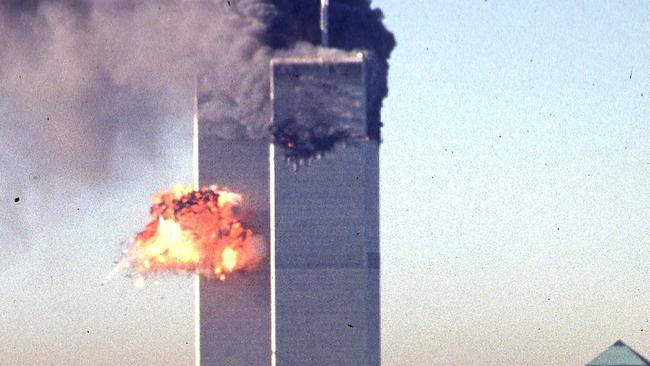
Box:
[270,54,380,365]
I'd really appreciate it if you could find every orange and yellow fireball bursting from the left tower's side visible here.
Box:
[127,184,261,281]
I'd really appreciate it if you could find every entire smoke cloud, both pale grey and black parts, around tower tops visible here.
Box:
[0,0,395,266]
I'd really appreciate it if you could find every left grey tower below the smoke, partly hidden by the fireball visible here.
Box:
[195,124,271,366]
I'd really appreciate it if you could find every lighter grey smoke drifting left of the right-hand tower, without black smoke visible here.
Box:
[0,0,275,175]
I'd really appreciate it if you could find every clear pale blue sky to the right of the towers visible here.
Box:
[375,0,650,365]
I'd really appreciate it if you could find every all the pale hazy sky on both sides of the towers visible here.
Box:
[0,0,650,366]
